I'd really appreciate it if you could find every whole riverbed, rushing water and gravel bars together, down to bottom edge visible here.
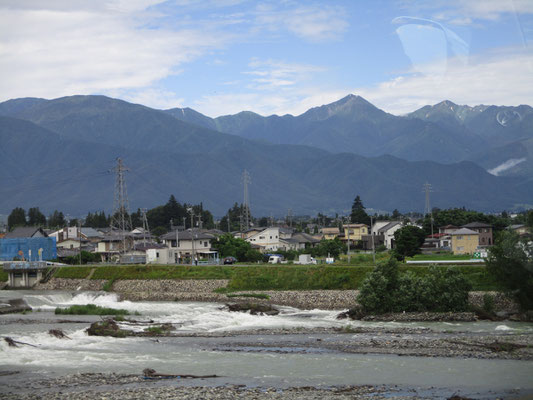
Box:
[0,291,533,399]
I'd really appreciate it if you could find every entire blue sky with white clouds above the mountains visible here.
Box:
[0,0,533,117]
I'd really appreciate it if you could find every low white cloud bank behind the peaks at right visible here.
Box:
[354,52,533,114]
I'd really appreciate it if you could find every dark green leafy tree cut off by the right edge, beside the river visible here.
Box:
[485,231,533,310]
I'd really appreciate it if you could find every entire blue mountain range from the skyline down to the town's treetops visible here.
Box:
[0,95,533,216]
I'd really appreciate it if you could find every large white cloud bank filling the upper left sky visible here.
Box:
[0,0,227,101]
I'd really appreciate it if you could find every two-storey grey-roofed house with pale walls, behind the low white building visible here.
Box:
[161,228,218,264]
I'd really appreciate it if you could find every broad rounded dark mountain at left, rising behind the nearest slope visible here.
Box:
[0,96,260,153]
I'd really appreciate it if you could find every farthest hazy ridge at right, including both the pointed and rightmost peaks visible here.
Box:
[166,95,533,175]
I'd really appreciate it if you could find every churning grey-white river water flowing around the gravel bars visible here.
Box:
[0,291,533,395]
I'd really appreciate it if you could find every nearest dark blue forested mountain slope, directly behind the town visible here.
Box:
[0,117,533,215]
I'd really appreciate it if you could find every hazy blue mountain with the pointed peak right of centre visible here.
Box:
[166,95,483,162]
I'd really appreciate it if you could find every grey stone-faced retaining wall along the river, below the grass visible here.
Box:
[30,278,517,312]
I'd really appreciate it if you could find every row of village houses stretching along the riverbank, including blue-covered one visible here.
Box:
[0,216,526,264]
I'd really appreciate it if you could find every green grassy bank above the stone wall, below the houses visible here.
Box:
[50,264,498,291]
